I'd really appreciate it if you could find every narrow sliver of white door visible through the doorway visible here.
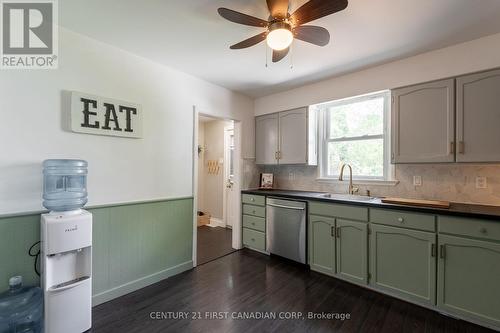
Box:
[224,128,238,228]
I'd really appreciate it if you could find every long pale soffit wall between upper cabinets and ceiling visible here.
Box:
[255,34,500,115]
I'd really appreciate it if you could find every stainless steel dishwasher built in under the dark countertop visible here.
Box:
[266,198,306,264]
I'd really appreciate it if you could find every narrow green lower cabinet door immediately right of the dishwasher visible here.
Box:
[309,215,335,275]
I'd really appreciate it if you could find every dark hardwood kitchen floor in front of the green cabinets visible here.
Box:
[91,250,492,333]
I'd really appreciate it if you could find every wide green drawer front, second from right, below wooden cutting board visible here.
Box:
[370,208,436,232]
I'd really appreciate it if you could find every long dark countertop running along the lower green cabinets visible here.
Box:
[241,189,500,222]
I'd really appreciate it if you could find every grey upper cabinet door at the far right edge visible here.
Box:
[457,70,500,162]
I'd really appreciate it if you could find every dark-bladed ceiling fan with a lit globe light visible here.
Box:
[218,0,347,62]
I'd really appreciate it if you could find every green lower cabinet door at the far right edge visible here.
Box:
[438,235,500,327]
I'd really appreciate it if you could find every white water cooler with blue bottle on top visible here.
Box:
[40,160,92,333]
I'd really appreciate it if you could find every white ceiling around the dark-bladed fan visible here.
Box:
[59,0,500,97]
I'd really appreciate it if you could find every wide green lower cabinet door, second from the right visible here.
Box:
[370,224,436,305]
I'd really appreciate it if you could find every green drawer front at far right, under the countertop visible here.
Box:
[438,216,500,241]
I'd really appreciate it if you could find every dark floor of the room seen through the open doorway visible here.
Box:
[197,226,236,265]
